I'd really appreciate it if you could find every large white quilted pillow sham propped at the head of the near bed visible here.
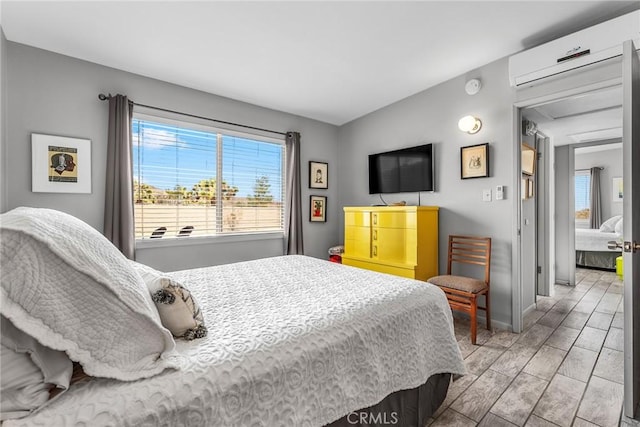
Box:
[0,208,175,381]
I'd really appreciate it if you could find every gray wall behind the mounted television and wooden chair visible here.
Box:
[338,59,514,327]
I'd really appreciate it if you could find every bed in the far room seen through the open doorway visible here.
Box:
[575,222,621,270]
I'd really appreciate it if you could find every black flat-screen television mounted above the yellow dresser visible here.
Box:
[369,144,435,194]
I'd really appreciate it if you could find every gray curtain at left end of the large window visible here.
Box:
[104,95,135,259]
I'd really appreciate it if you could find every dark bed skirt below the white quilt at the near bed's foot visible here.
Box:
[326,374,451,427]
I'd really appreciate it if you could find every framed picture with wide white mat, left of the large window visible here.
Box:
[31,133,91,193]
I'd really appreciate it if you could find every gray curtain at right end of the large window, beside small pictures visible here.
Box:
[284,132,304,255]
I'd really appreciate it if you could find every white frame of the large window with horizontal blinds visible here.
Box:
[131,110,287,244]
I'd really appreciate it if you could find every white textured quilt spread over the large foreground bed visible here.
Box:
[6,256,465,427]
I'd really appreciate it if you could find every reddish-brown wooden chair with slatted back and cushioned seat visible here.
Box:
[427,235,491,345]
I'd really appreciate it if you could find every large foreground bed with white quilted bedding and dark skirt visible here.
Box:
[1,210,465,427]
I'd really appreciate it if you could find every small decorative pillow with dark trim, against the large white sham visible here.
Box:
[130,261,207,340]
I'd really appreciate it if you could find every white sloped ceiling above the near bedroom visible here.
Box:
[0,0,637,125]
